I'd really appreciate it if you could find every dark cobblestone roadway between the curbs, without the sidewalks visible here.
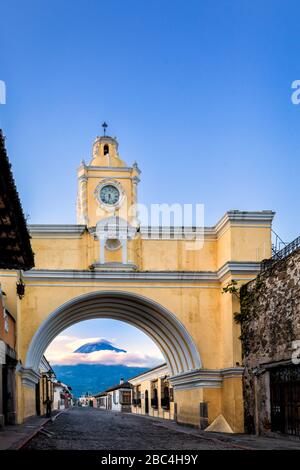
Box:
[22,407,228,450]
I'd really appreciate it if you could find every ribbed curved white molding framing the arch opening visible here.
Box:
[25,291,201,375]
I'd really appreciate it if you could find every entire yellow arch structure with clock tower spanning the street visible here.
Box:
[0,126,274,432]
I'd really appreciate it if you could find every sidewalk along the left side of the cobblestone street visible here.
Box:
[0,413,60,450]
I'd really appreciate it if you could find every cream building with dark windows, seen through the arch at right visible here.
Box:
[129,364,173,424]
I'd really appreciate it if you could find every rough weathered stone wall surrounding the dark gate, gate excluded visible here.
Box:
[236,250,300,433]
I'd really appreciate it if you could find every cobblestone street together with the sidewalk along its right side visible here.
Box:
[24,407,300,450]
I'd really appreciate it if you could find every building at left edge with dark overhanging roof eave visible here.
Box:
[0,129,34,428]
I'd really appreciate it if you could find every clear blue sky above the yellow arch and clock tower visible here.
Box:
[0,0,300,364]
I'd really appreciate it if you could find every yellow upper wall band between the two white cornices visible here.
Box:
[27,225,271,271]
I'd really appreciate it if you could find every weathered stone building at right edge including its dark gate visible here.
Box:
[238,237,300,436]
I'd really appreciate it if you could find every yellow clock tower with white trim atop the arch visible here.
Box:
[77,129,140,268]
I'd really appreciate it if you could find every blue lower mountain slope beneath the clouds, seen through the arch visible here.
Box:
[53,364,149,397]
